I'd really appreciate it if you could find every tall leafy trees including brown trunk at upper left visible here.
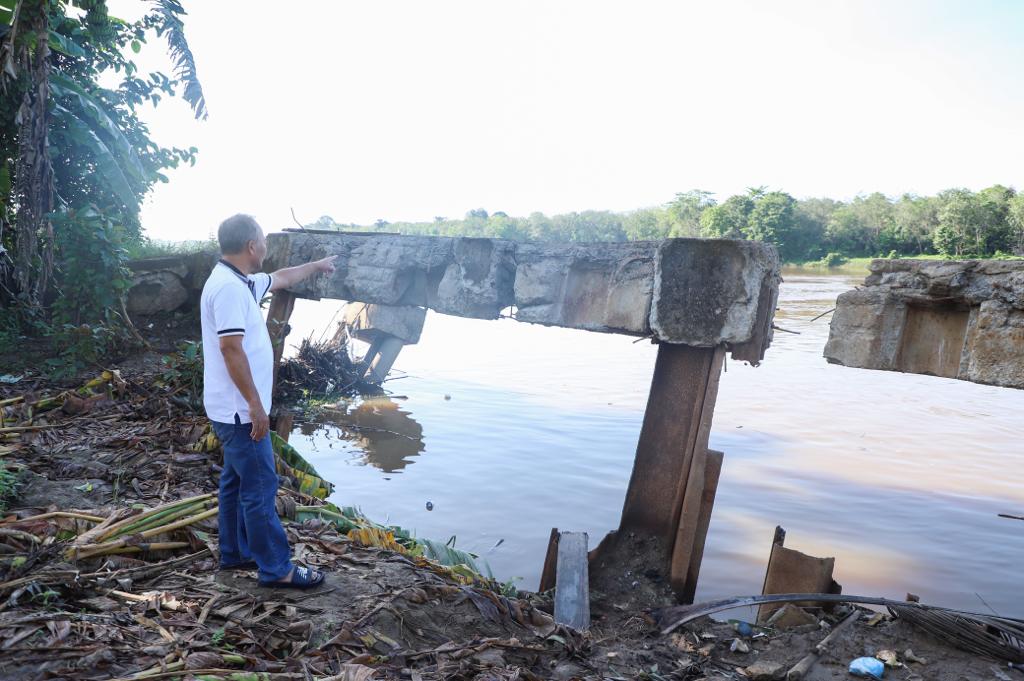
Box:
[0,0,207,310]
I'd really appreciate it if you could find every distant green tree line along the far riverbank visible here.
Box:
[317,184,1024,263]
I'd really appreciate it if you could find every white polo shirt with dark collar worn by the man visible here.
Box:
[200,260,273,423]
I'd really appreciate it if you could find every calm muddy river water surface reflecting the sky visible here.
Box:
[282,270,1024,616]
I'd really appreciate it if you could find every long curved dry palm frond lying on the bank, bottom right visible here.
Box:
[651,594,1024,663]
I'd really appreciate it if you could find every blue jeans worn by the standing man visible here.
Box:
[212,416,292,582]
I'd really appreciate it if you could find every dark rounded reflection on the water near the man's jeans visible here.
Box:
[302,396,424,473]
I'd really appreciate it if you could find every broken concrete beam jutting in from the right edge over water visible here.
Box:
[824,259,1024,388]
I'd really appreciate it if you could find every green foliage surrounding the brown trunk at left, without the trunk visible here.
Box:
[0,0,206,366]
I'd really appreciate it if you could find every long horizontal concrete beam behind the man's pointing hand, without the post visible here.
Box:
[267,230,779,364]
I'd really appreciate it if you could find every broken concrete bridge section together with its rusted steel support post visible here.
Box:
[267,229,780,601]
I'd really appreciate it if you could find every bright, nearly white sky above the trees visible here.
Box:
[109,0,1024,241]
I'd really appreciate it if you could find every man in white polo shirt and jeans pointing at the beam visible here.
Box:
[200,214,336,589]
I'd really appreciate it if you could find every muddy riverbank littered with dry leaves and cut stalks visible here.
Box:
[0,327,1007,681]
